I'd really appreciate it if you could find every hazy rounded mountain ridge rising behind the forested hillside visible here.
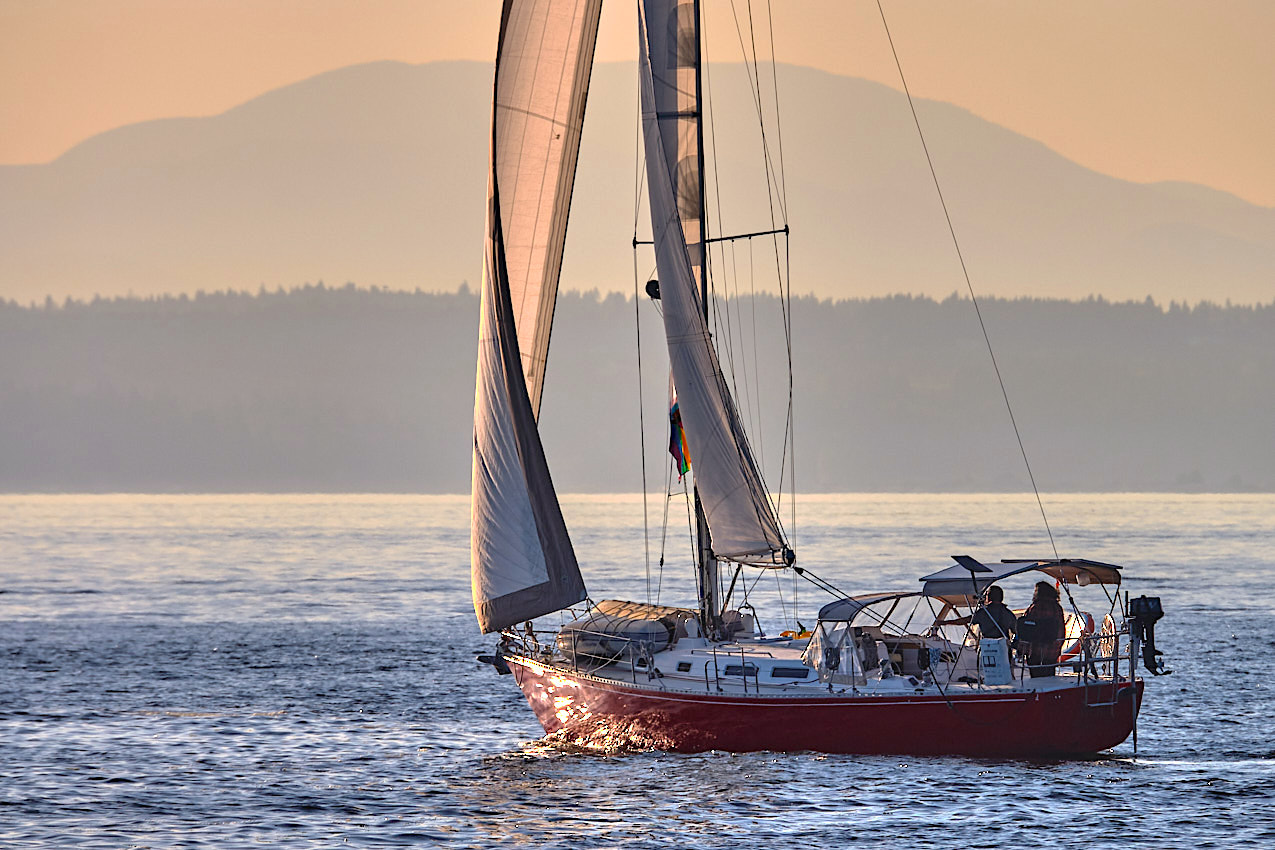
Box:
[0,62,1275,303]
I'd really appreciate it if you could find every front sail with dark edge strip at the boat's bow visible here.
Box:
[470,0,601,632]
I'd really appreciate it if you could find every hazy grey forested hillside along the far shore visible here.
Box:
[0,284,1275,492]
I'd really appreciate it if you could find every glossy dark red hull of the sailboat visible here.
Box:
[506,656,1142,757]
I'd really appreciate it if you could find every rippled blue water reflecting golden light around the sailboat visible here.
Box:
[0,494,1275,849]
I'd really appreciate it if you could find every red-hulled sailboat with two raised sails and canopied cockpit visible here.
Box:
[470,0,1163,757]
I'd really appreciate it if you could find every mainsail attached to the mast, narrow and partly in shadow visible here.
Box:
[639,0,791,565]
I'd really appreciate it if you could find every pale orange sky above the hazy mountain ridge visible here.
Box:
[0,0,1275,206]
